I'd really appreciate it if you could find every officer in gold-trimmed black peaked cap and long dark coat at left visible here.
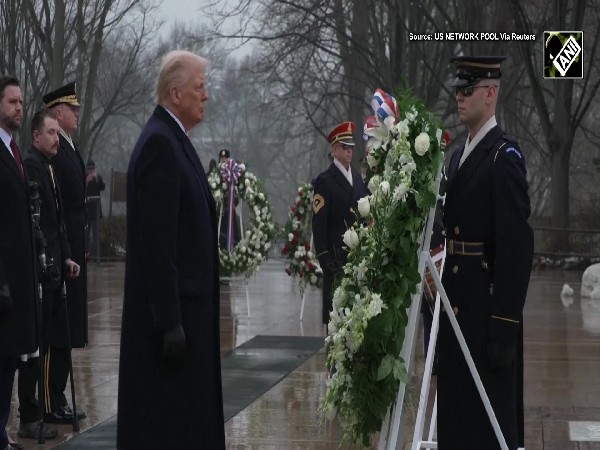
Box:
[43,82,88,423]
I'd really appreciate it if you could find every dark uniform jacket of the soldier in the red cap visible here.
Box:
[312,163,367,272]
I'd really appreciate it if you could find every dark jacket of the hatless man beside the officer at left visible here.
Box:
[23,147,71,348]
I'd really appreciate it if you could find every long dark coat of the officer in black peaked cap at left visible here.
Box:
[52,135,88,348]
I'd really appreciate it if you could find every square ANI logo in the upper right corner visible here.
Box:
[544,31,583,79]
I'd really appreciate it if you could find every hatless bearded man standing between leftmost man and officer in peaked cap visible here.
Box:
[17,109,79,439]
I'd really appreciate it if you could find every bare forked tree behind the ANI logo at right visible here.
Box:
[510,0,600,230]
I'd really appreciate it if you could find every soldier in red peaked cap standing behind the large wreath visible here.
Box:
[312,122,367,324]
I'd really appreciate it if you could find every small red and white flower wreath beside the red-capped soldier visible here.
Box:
[281,183,323,295]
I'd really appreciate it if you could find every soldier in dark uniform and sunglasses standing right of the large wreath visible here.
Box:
[437,56,533,450]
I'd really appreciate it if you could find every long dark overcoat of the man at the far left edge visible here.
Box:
[0,141,38,357]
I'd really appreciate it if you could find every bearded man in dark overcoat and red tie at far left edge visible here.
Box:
[0,76,38,450]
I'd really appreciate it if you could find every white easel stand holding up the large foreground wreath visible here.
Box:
[378,166,508,450]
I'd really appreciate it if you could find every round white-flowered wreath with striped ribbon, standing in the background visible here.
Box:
[208,159,275,279]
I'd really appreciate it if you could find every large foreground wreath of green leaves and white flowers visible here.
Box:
[320,91,443,446]
